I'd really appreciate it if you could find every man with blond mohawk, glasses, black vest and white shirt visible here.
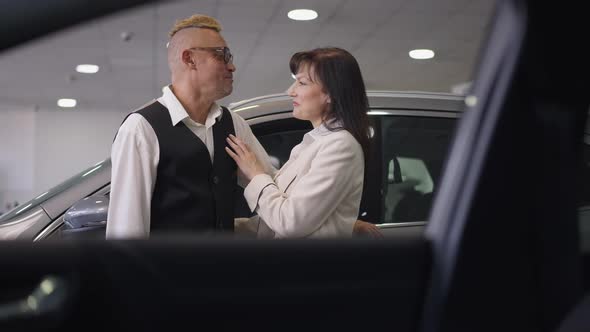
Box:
[106,15,273,239]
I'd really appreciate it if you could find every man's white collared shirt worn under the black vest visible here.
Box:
[106,86,274,239]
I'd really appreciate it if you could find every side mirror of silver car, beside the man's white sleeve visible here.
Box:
[64,195,109,230]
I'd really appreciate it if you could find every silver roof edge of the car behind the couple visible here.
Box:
[228,90,465,119]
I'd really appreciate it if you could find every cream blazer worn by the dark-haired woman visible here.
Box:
[244,125,364,238]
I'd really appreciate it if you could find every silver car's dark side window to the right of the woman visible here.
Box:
[380,116,456,223]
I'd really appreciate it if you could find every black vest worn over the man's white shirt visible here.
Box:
[126,101,237,232]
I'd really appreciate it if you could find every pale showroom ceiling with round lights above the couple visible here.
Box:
[0,0,495,112]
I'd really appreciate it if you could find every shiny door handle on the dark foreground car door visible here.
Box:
[0,275,72,323]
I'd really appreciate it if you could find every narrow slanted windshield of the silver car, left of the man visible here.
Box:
[0,159,111,225]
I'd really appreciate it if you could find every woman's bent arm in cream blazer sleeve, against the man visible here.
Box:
[231,135,364,237]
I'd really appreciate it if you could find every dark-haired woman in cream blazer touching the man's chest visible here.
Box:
[226,48,378,238]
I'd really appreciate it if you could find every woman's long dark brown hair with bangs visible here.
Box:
[289,47,369,163]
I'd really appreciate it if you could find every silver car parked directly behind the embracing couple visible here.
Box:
[0,91,464,241]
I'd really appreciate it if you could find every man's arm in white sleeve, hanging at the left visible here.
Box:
[106,114,159,239]
